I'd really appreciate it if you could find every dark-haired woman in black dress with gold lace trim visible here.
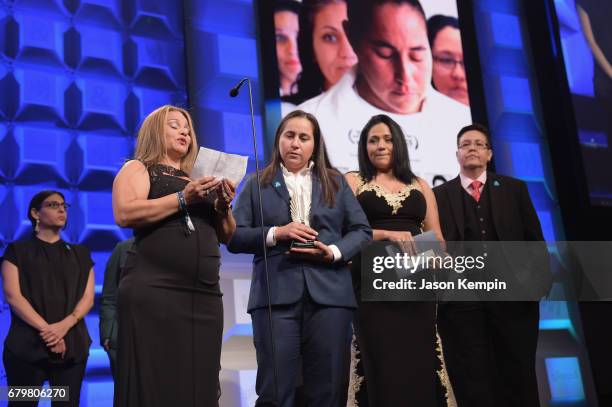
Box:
[346,115,452,407]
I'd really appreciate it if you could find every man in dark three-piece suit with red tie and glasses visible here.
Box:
[434,124,550,407]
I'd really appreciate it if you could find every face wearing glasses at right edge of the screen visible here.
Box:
[431,26,470,106]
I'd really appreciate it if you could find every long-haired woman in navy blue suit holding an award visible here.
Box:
[228,110,372,407]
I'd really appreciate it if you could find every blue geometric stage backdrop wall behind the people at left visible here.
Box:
[0,0,187,406]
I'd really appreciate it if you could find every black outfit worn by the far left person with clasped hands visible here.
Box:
[3,237,93,406]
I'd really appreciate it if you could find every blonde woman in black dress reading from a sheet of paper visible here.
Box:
[113,106,236,407]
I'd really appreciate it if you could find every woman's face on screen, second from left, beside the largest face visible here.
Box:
[312,2,357,90]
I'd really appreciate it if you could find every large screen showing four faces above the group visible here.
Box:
[257,0,472,185]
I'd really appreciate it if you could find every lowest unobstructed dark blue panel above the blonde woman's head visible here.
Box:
[126,37,185,89]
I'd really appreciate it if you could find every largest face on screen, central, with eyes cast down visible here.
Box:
[356,3,432,114]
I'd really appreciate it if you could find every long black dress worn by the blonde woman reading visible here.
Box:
[115,165,223,407]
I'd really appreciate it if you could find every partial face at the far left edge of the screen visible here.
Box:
[274,11,302,95]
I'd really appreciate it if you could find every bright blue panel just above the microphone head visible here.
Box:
[217,35,258,78]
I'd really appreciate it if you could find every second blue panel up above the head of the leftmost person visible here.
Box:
[15,69,69,124]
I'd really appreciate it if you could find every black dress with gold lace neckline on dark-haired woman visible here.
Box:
[353,179,439,407]
